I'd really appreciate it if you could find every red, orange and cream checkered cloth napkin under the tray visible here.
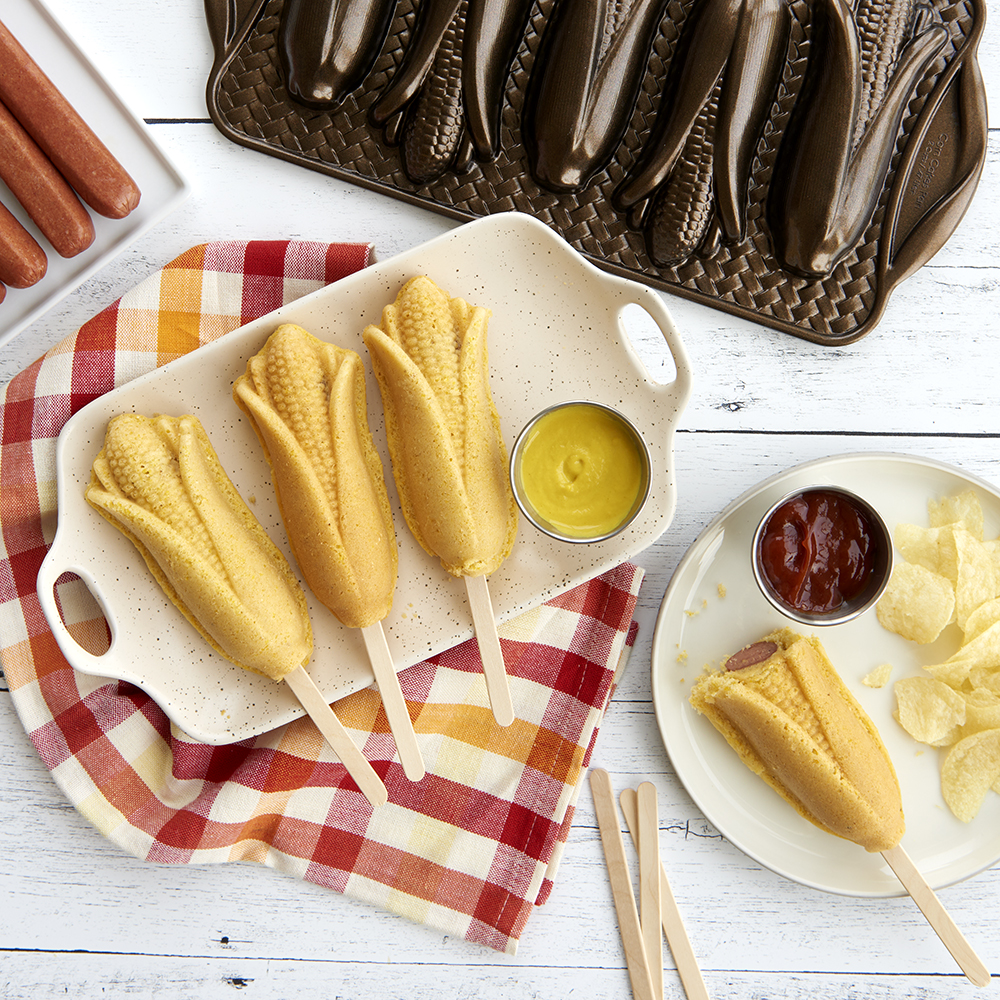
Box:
[0,242,642,953]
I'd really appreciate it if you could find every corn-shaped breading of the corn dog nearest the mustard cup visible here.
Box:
[363,276,517,576]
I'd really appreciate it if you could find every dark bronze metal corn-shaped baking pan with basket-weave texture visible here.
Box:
[205,0,987,345]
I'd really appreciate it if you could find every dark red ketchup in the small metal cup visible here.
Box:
[758,490,875,614]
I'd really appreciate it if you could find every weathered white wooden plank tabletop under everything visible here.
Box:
[0,0,1000,1000]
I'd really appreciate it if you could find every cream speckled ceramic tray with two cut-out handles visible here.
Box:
[38,213,690,743]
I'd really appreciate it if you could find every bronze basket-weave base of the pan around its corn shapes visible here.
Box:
[206,0,986,345]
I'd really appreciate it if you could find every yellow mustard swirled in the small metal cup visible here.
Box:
[520,403,643,538]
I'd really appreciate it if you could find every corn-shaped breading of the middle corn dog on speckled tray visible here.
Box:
[233,324,398,628]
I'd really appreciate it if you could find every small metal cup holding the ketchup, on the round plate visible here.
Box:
[750,483,892,626]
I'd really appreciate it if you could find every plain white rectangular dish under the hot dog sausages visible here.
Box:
[0,0,190,347]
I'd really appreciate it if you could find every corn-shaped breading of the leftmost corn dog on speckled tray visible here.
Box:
[86,414,313,680]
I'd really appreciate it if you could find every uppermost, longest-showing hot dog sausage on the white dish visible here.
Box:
[0,15,139,219]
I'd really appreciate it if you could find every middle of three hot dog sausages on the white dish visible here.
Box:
[0,97,94,257]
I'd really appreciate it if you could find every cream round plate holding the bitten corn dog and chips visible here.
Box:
[652,453,1000,896]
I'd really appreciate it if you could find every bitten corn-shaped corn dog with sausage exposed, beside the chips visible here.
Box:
[691,629,904,851]
